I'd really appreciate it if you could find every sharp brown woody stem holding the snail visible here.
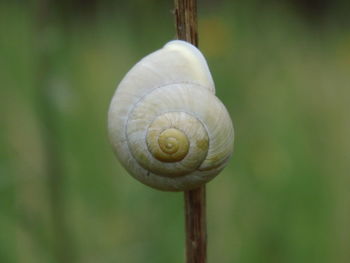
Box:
[175,0,207,263]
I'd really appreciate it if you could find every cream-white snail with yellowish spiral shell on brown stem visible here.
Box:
[108,40,233,191]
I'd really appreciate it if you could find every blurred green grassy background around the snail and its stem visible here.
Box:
[0,0,350,263]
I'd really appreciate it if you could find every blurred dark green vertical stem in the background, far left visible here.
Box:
[36,0,74,263]
